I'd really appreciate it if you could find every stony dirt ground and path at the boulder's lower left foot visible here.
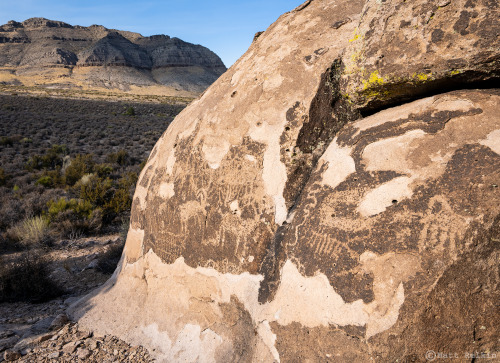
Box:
[0,235,152,362]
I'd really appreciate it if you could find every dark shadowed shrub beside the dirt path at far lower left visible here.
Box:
[0,252,64,303]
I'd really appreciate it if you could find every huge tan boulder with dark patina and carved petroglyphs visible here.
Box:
[68,0,500,362]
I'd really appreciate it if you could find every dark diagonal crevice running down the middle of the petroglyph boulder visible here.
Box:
[259,58,360,303]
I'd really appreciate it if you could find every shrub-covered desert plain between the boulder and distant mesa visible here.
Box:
[0,96,182,302]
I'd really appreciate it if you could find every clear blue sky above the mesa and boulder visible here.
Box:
[0,0,304,67]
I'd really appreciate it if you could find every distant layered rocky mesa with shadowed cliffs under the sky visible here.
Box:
[0,18,226,95]
